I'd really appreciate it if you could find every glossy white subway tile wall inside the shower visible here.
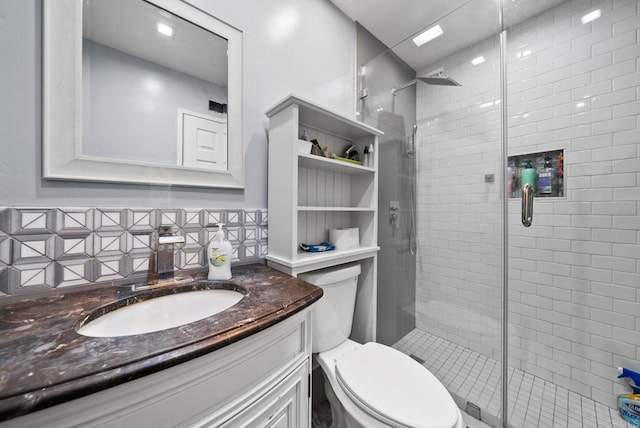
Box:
[416,0,640,406]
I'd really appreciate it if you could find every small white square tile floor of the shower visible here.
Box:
[393,328,636,428]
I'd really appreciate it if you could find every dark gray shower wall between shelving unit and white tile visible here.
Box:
[357,25,416,345]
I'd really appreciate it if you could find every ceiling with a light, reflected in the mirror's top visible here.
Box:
[82,0,227,86]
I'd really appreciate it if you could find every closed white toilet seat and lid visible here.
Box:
[335,342,459,428]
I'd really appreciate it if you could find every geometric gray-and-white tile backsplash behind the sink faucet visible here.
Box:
[0,207,268,297]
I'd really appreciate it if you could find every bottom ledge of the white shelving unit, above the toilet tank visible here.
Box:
[267,246,380,273]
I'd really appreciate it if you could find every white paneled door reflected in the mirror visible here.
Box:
[178,110,227,171]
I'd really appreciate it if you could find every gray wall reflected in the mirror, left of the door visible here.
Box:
[82,39,227,165]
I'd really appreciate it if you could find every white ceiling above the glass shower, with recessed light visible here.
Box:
[331,0,565,71]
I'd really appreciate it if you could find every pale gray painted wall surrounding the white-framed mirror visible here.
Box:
[0,0,355,208]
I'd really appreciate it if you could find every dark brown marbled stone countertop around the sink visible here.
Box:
[0,264,322,420]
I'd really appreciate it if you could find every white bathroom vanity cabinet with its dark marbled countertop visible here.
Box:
[0,265,322,428]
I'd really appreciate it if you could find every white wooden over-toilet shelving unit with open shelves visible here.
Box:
[267,95,382,342]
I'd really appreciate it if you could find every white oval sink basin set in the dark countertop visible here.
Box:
[78,290,244,337]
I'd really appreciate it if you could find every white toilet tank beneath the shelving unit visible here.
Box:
[298,264,361,352]
